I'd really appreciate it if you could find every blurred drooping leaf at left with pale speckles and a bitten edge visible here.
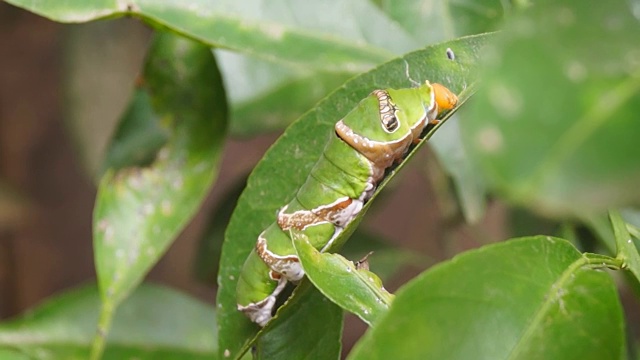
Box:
[93,34,226,354]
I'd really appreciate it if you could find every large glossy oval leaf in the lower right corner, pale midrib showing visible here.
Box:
[349,236,624,360]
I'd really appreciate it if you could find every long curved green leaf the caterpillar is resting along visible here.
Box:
[217,35,488,357]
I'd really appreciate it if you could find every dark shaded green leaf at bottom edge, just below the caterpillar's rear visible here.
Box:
[254,279,343,360]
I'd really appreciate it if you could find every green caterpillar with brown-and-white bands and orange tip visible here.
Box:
[236,81,458,326]
